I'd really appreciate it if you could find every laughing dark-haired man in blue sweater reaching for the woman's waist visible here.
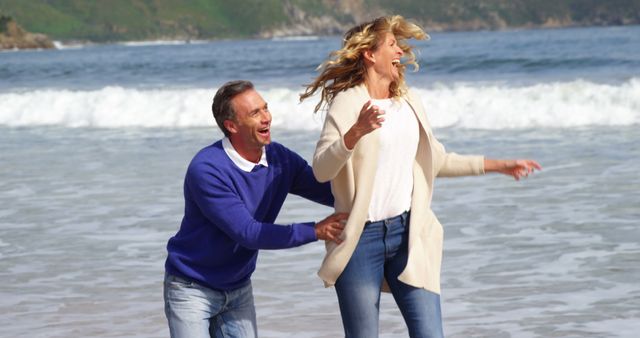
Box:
[164,81,347,338]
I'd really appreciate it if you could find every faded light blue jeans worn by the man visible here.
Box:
[164,274,258,338]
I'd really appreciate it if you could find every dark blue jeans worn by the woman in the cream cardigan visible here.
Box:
[336,213,444,338]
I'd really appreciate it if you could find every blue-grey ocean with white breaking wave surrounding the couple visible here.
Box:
[0,26,640,338]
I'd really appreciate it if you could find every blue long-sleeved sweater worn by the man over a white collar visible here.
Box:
[165,141,333,290]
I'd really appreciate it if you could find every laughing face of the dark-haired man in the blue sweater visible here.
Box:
[225,89,271,155]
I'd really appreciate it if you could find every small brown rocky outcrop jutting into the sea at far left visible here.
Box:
[0,15,55,49]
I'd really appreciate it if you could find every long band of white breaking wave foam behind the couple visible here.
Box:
[0,78,640,130]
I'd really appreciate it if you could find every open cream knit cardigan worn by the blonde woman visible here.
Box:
[313,85,484,294]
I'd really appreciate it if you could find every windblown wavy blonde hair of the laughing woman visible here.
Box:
[300,15,429,112]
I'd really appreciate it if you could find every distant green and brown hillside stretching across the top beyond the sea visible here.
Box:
[0,0,640,42]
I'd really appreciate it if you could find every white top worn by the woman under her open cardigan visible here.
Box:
[368,99,420,222]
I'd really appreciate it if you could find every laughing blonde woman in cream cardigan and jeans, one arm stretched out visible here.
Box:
[301,16,540,338]
